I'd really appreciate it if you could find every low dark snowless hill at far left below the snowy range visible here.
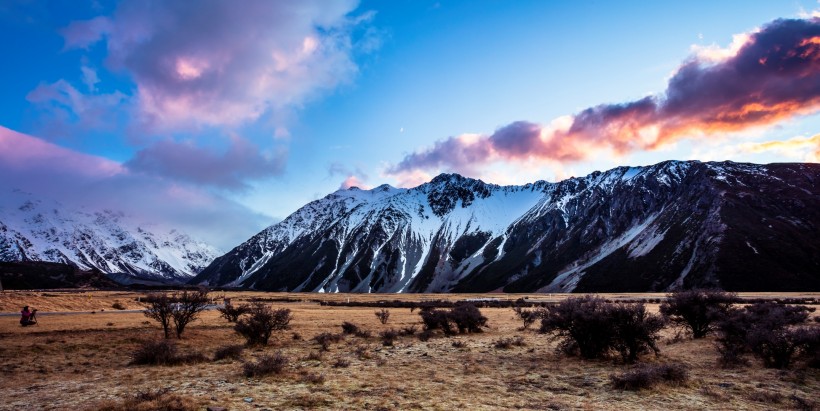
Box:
[0,261,120,290]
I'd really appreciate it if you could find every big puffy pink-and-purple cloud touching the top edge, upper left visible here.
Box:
[62,0,372,131]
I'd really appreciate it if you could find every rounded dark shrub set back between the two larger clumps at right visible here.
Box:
[660,290,737,338]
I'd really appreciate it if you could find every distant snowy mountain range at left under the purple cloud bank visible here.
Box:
[0,190,220,283]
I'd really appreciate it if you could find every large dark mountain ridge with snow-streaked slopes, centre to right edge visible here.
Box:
[191,161,820,292]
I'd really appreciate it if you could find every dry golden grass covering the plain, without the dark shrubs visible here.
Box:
[0,292,820,410]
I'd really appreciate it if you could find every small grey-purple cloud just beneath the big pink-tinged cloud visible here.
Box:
[125,136,287,190]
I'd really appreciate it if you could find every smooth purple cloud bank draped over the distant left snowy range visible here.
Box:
[0,126,273,250]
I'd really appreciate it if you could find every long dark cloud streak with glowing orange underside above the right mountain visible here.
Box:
[386,18,820,180]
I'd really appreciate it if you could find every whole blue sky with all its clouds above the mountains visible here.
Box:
[0,0,820,251]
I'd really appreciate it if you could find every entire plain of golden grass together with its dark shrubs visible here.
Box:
[0,292,820,410]
